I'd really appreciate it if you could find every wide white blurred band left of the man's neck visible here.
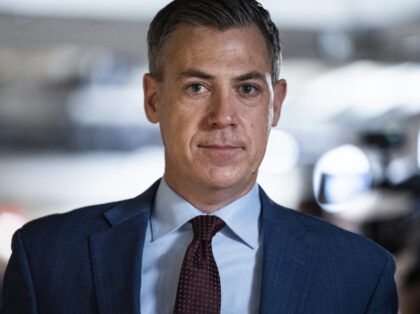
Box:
[0,146,164,219]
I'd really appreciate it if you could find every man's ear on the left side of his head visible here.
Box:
[143,73,160,123]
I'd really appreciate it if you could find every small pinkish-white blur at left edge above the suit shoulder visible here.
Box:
[0,206,27,261]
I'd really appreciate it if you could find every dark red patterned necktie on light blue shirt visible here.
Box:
[174,215,225,314]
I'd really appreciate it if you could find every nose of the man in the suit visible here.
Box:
[208,91,238,129]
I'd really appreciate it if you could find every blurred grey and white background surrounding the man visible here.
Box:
[0,0,420,314]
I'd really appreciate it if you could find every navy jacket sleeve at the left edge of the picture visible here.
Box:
[0,231,37,314]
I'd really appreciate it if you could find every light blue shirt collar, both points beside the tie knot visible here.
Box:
[150,178,261,248]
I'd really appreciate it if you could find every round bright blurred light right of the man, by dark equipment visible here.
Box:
[313,145,372,213]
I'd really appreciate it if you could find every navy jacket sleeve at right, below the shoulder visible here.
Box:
[366,256,398,314]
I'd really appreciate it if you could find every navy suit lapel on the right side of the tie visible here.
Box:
[260,189,316,314]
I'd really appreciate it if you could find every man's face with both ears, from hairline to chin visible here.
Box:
[144,25,286,196]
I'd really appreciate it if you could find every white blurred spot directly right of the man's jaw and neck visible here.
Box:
[261,129,299,174]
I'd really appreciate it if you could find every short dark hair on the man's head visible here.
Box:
[147,0,282,82]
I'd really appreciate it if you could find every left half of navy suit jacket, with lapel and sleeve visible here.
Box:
[0,182,158,314]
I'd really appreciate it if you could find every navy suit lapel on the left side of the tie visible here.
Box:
[89,181,159,314]
